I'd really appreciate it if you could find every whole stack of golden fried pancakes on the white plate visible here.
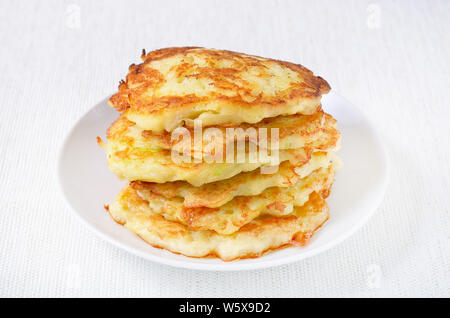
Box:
[98,47,340,260]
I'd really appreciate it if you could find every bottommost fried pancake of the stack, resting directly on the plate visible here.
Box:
[109,187,328,261]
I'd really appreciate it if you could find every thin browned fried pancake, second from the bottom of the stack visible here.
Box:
[131,165,335,234]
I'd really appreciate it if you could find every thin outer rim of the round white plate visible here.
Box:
[56,91,390,272]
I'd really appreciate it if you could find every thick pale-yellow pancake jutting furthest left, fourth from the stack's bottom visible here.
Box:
[97,115,340,186]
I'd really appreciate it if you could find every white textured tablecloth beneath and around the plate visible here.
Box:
[0,0,450,297]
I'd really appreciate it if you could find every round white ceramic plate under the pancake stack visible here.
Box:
[58,93,388,271]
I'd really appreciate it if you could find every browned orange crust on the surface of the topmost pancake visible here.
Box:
[109,47,330,114]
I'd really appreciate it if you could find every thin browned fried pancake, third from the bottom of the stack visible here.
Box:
[131,152,339,208]
